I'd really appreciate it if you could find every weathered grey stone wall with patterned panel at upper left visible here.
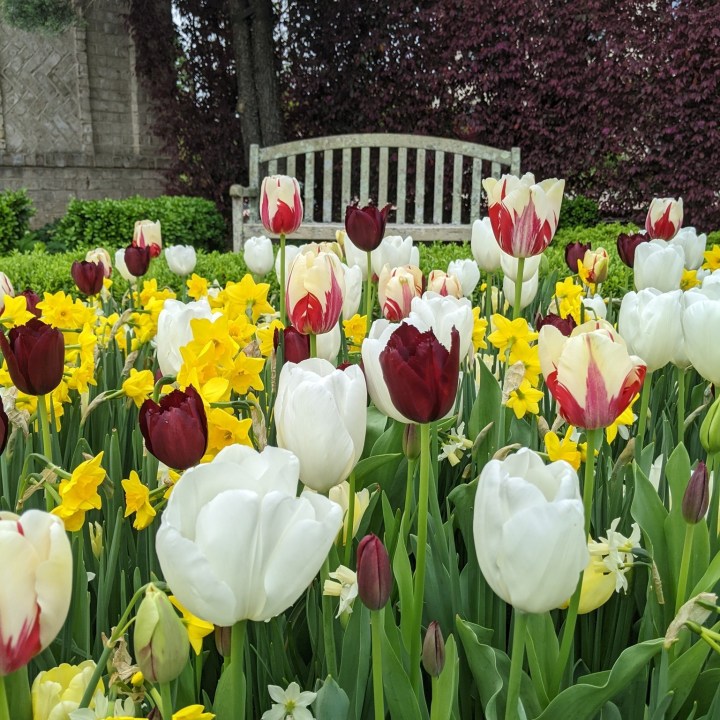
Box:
[0,0,167,226]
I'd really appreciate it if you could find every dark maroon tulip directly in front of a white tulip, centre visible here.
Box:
[380,323,460,423]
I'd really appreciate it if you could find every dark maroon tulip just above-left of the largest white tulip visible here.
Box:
[140,385,208,470]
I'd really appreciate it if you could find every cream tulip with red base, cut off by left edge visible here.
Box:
[0,510,73,676]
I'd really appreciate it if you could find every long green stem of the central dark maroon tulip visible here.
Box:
[410,423,430,695]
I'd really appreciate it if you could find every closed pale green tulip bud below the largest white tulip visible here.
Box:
[134,584,190,683]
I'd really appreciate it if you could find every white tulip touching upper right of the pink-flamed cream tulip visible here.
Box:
[618,288,684,372]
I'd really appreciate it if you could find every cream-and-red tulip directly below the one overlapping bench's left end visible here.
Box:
[286,251,345,335]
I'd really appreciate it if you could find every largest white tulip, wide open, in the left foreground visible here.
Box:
[155,445,342,627]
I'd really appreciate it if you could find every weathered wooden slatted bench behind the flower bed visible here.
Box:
[230,134,520,252]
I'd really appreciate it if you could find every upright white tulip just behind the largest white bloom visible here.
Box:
[275,358,367,492]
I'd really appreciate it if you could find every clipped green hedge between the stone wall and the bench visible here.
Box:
[53,195,228,250]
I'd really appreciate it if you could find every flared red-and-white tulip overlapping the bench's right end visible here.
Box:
[483,173,565,257]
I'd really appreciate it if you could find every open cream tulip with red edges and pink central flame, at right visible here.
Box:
[538,320,647,430]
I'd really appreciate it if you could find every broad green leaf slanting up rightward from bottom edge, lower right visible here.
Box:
[538,638,663,720]
